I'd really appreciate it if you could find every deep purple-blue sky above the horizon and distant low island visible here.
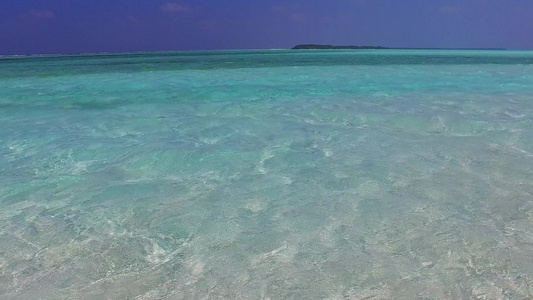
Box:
[0,0,533,54]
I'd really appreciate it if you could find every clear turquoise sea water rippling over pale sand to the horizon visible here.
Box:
[0,50,533,299]
